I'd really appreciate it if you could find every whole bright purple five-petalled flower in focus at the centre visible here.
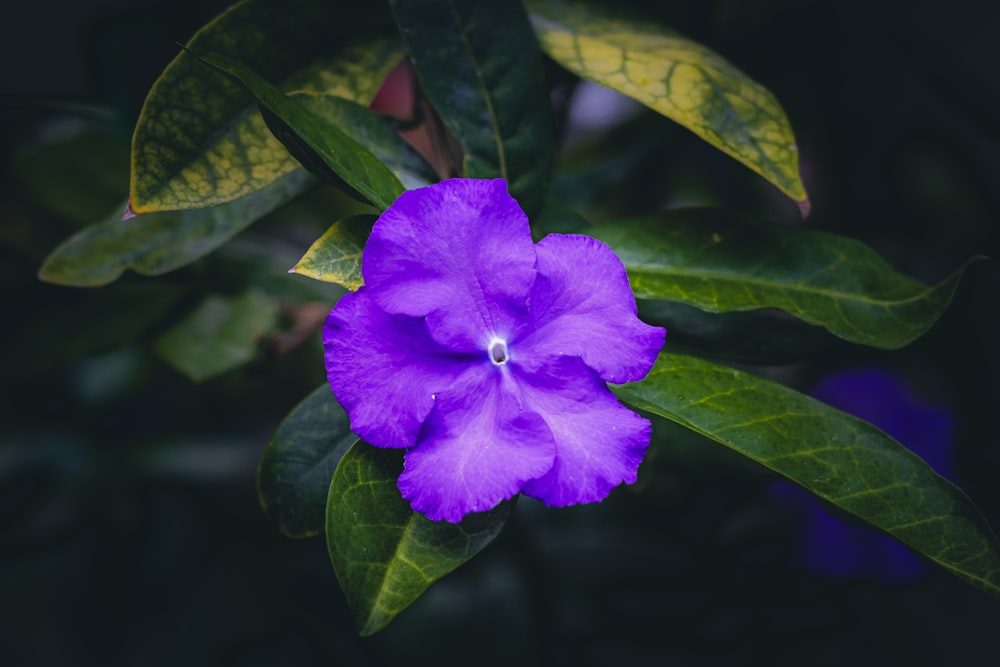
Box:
[324,179,665,522]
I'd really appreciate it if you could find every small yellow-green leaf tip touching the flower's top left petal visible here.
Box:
[289,215,375,290]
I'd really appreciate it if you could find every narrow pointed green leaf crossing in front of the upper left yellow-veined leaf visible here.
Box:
[191,54,403,210]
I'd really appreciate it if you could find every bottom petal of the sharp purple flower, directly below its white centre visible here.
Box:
[399,362,555,522]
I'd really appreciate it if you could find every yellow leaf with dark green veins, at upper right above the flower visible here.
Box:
[525,0,809,213]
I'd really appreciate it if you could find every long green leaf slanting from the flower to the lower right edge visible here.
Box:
[613,354,1000,596]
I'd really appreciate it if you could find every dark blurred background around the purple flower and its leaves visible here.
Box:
[0,0,1000,666]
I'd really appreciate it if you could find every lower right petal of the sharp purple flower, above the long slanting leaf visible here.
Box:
[517,357,651,507]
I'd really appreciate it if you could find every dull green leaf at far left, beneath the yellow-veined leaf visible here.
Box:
[38,169,315,287]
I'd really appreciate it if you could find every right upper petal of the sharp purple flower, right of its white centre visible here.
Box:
[512,234,666,383]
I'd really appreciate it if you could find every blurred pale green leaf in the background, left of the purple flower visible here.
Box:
[154,290,278,382]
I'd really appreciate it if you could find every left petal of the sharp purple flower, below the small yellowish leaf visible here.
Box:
[323,287,469,447]
